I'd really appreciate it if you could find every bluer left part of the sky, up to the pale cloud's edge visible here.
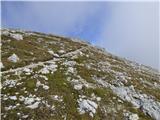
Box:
[2,2,109,42]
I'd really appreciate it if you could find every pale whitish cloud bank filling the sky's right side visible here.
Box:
[96,2,160,68]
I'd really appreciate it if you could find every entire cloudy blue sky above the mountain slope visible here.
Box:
[1,1,160,68]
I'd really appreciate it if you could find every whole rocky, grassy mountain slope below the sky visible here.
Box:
[1,29,160,120]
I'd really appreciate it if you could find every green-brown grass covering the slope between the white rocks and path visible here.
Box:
[1,29,160,120]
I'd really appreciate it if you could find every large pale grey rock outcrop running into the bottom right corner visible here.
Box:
[113,87,160,120]
